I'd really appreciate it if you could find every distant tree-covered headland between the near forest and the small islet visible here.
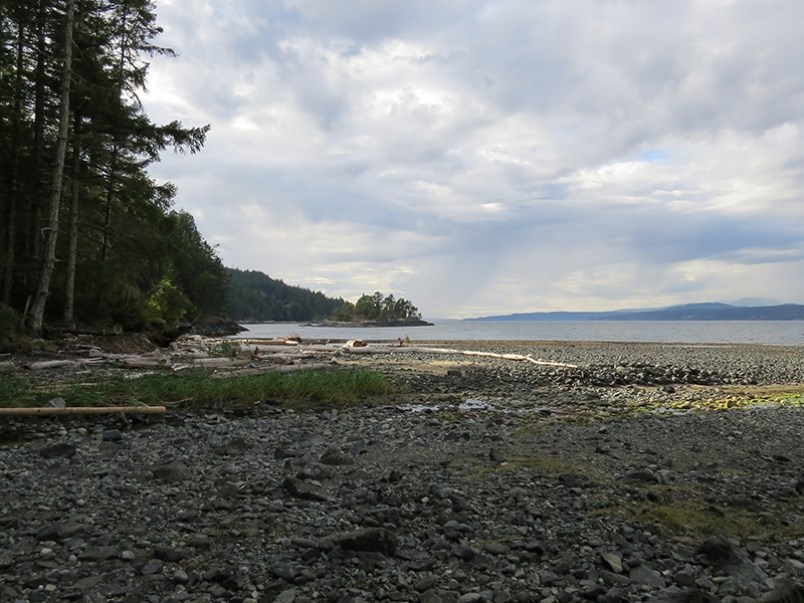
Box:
[226,268,346,322]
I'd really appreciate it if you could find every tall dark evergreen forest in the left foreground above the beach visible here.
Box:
[0,0,227,340]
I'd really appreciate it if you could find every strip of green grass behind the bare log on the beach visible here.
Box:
[0,369,393,408]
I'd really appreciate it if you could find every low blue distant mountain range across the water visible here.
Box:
[466,302,804,321]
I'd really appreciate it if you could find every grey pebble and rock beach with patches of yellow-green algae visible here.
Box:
[0,342,804,603]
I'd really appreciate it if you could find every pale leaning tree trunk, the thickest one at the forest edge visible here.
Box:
[28,0,75,334]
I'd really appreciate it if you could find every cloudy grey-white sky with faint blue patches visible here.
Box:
[145,0,804,318]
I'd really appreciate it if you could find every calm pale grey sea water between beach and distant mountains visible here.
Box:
[231,319,804,346]
